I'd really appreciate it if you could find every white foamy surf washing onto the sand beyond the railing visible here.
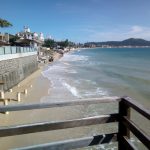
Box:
[42,51,108,98]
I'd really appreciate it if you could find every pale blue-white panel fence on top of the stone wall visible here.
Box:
[0,46,37,55]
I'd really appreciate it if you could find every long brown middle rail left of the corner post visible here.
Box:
[0,114,118,137]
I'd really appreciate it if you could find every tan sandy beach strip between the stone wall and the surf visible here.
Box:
[0,48,84,105]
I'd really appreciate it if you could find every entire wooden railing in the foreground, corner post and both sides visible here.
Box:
[0,97,150,150]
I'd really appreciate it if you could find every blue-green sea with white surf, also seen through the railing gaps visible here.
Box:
[41,48,150,149]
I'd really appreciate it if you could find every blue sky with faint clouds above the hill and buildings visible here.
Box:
[0,0,150,42]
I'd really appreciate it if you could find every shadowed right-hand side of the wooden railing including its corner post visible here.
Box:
[118,97,150,150]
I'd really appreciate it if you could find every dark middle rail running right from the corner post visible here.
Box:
[122,117,150,149]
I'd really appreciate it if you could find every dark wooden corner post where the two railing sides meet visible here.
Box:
[118,98,130,150]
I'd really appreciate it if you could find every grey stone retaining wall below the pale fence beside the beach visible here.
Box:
[0,53,38,91]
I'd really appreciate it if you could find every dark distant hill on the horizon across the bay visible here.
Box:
[84,38,150,47]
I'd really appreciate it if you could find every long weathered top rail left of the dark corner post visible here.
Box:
[0,97,120,112]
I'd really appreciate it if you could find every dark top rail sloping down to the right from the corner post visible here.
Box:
[122,97,150,120]
